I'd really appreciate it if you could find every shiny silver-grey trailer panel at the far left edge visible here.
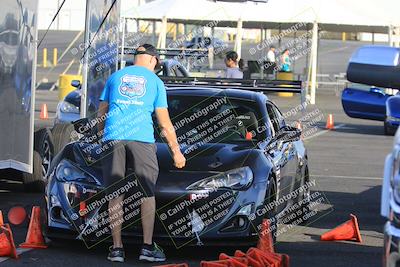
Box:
[0,0,38,172]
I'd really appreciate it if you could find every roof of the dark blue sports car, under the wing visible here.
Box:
[167,85,268,102]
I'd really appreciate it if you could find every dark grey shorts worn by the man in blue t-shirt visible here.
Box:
[102,140,158,197]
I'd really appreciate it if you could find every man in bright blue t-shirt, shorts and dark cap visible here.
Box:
[98,44,186,262]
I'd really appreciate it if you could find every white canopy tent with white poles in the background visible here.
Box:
[121,0,400,104]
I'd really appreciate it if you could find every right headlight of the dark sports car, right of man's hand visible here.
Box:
[186,167,253,190]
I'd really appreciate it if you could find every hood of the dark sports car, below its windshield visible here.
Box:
[71,142,255,193]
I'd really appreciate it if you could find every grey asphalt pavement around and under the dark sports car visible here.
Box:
[0,89,393,267]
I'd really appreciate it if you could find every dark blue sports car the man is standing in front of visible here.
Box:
[44,80,310,247]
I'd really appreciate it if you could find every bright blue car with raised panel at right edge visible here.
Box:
[342,46,400,135]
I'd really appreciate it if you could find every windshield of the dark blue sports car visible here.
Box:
[155,95,265,146]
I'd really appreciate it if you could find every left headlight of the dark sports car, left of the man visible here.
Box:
[56,159,96,183]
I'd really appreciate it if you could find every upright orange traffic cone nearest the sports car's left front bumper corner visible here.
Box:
[19,206,47,248]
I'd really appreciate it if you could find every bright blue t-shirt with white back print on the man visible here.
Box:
[100,66,168,143]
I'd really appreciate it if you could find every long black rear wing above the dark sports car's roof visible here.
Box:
[161,77,304,95]
